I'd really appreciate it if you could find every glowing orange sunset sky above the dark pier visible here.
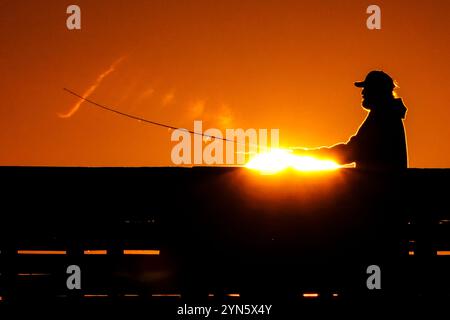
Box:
[0,0,450,167]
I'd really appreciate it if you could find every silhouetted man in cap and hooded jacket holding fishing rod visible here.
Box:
[294,71,408,170]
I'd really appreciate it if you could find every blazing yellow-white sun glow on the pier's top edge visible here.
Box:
[245,149,341,174]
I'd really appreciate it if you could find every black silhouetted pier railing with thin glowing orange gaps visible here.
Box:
[0,167,450,312]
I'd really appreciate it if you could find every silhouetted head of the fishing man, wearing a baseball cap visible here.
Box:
[355,71,396,110]
